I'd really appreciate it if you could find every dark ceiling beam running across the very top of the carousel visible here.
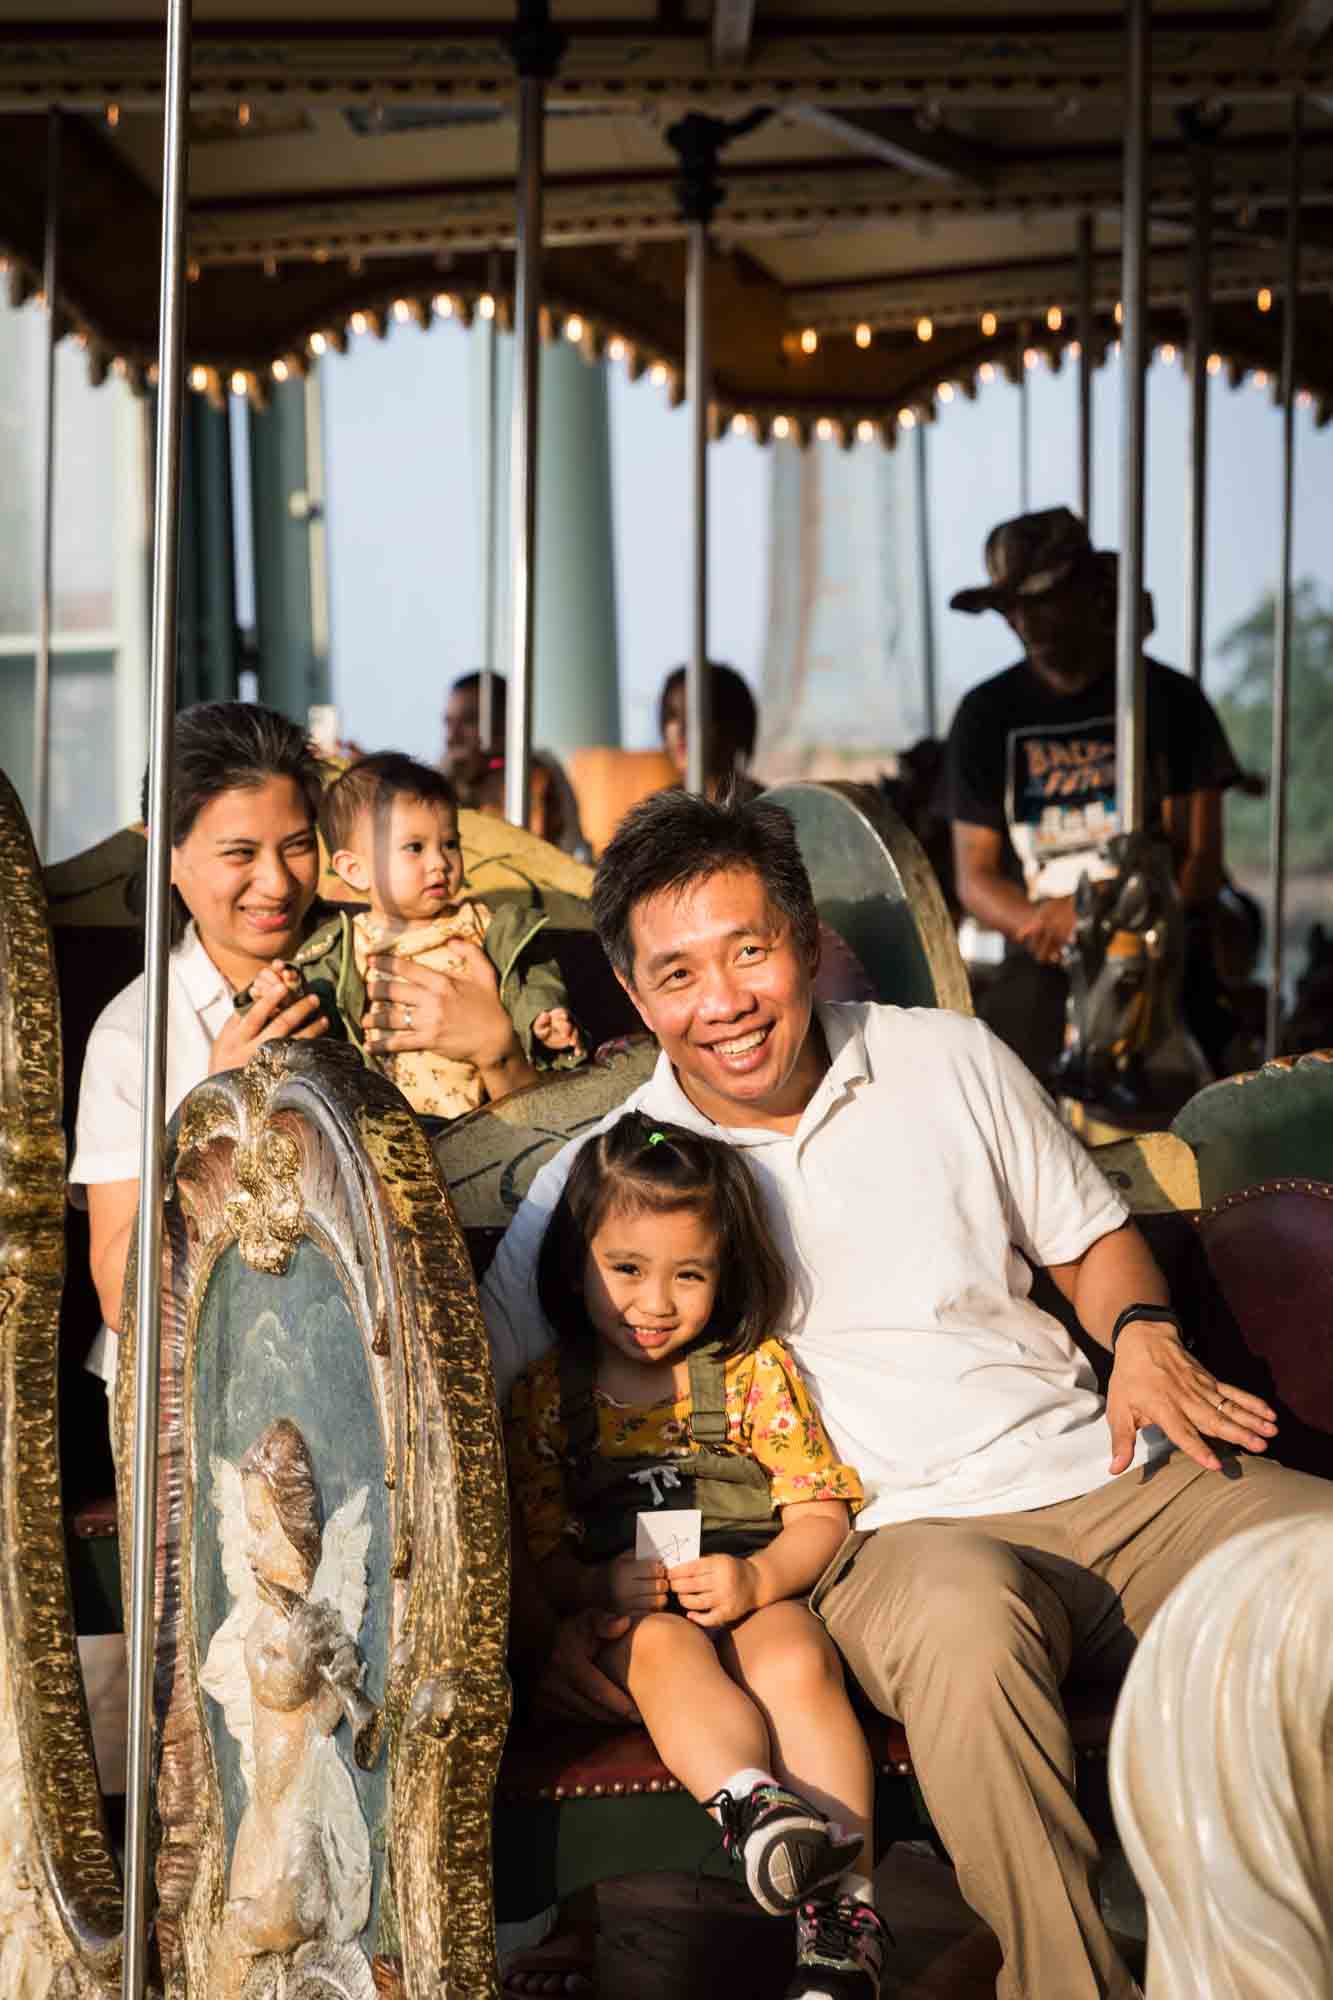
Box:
[0,21,1333,112]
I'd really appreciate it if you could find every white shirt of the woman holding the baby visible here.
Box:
[68,924,232,1388]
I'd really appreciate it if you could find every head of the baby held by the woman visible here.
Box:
[320,750,462,924]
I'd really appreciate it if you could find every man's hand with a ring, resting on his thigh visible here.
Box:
[1107,1320,1277,1472]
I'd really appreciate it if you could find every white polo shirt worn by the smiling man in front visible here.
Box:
[482,1002,1161,1528]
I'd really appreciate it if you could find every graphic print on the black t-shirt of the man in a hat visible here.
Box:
[1005,716,1121,900]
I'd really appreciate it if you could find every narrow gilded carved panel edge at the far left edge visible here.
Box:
[0,776,120,2000]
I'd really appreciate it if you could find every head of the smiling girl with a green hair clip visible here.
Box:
[536,1112,791,1362]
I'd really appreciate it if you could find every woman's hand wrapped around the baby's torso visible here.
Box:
[362,938,534,1098]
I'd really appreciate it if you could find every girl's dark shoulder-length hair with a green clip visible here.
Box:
[536,1112,791,1360]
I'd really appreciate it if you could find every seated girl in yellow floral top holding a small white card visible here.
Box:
[508,1112,887,2000]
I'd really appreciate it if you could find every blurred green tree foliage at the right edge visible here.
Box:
[1217,578,1333,868]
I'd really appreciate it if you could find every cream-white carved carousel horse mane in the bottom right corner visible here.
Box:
[1111,1514,1333,2000]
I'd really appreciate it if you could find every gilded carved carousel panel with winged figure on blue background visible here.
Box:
[116,1044,508,2000]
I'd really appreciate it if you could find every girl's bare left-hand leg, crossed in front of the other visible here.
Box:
[598,1612,773,1802]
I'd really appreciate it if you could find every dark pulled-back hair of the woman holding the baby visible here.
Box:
[140,702,322,944]
